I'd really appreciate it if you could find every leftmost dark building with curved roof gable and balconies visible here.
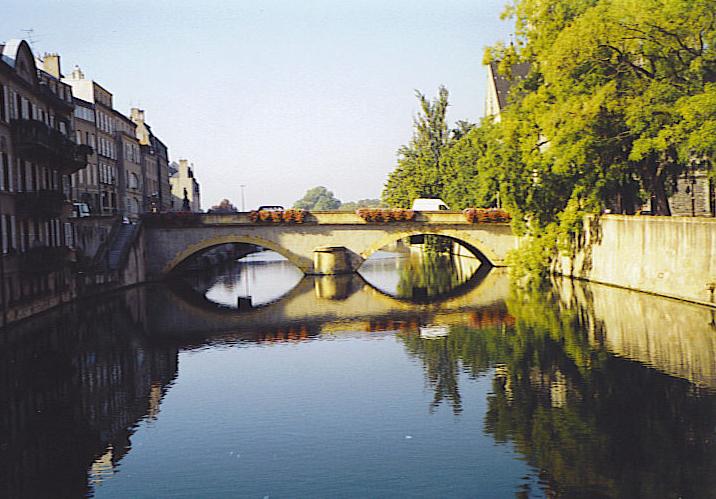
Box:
[0,40,91,324]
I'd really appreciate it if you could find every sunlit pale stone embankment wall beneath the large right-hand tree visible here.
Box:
[552,215,716,307]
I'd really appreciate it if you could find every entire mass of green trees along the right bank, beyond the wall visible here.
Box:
[383,0,716,230]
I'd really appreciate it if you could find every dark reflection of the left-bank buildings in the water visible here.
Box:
[0,299,177,497]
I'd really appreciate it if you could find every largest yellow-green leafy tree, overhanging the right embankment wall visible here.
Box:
[488,0,716,217]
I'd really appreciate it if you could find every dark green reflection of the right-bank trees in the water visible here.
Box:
[399,292,716,497]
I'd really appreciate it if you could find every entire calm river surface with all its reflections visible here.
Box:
[0,252,716,498]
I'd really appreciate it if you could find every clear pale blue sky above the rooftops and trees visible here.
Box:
[0,0,511,209]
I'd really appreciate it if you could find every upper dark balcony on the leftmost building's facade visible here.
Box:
[10,120,92,175]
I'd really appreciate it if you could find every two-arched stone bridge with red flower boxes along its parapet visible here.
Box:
[144,211,519,279]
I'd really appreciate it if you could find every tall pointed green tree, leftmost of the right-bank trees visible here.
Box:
[383,86,450,208]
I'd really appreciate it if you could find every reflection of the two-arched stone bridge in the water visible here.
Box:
[149,252,498,337]
